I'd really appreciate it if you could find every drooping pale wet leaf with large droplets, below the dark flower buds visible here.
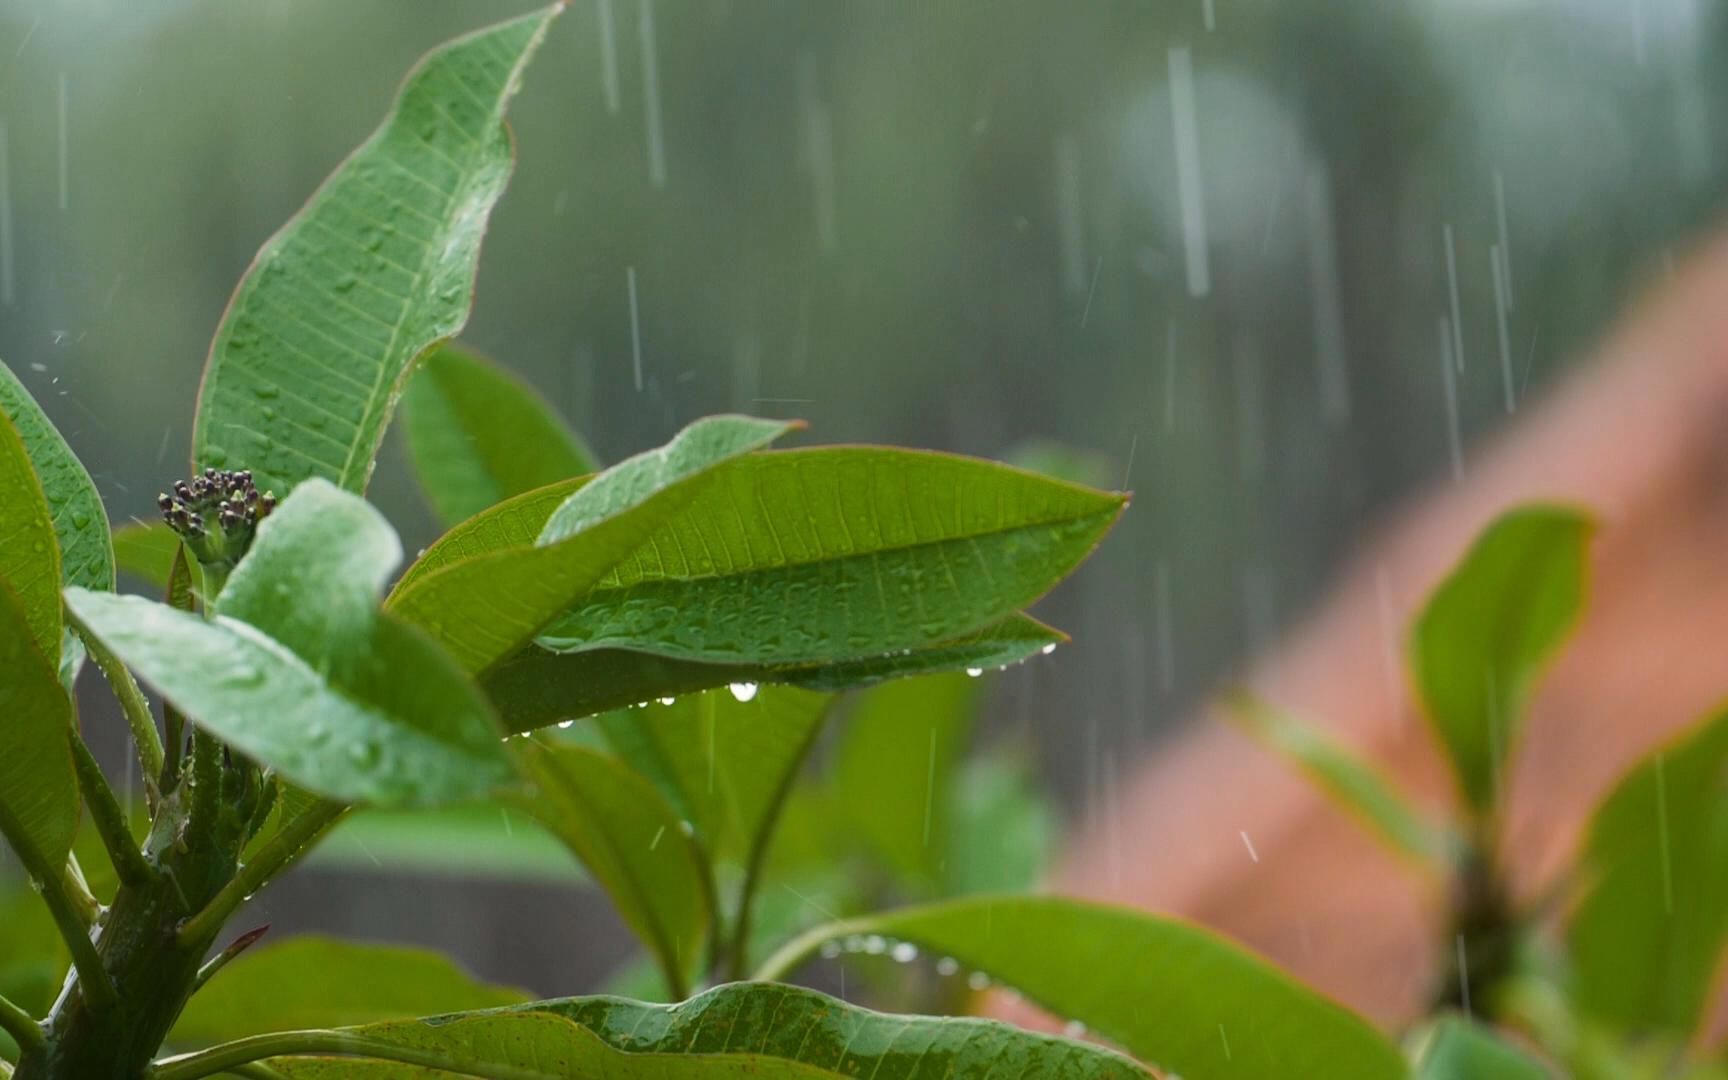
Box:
[66,588,510,805]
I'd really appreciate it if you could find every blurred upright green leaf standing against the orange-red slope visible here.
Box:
[1410,506,1593,814]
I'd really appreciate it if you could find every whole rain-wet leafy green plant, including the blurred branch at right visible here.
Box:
[0,7,1707,1080]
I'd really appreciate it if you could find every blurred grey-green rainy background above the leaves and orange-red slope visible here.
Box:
[0,0,1728,990]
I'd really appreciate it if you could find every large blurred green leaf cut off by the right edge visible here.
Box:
[1569,714,1728,1039]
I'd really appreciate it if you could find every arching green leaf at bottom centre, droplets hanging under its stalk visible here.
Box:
[766,897,1408,1080]
